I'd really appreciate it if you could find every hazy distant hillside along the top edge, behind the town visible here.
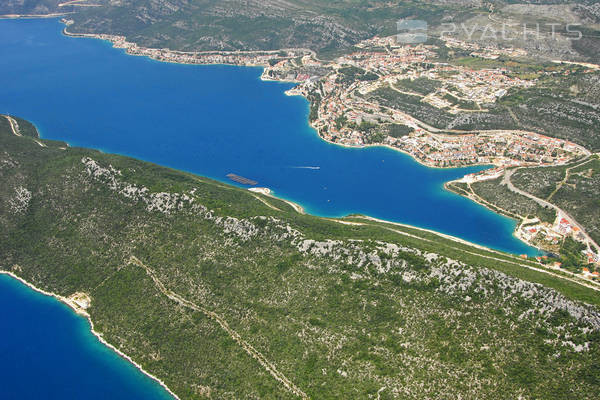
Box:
[0,0,600,61]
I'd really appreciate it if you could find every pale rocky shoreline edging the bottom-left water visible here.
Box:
[0,269,181,400]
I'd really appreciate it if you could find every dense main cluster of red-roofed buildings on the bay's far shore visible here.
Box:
[263,38,556,167]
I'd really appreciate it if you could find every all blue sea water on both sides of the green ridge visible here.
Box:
[0,20,536,399]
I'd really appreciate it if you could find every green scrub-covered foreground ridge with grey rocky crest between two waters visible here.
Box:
[0,118,600,399]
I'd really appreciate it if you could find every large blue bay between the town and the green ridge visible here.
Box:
[0,20,537,254]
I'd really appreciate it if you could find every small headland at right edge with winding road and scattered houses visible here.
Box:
[446,154,600,280]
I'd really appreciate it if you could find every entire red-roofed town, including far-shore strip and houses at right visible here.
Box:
[64,21,600,280]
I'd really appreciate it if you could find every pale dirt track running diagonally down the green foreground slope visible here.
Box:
[129,256,308,399]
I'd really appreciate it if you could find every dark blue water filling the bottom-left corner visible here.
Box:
[0,275,172,400]
